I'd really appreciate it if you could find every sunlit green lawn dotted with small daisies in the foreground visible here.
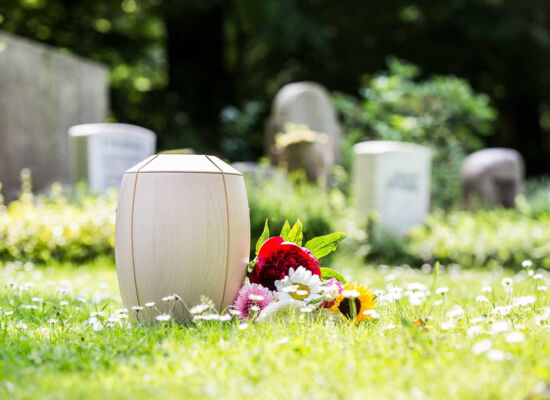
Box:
[0,258,550,400]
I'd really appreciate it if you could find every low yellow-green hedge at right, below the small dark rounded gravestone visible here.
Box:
[408,209,550,269]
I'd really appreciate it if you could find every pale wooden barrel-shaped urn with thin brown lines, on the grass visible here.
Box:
[115,154,250,321]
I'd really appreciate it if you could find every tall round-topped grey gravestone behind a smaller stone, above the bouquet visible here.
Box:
[265,82,342,166]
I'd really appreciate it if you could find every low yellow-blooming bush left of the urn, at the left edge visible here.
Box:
[0,173,117,265]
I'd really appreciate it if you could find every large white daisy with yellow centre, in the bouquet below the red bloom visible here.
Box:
[275,267,322,307]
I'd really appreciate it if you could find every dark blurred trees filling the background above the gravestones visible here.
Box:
[0,0,550,170]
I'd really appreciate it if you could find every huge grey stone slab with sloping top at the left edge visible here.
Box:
[0,33,108,200]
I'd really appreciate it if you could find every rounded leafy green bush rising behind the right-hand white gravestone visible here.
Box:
[335,59,496,208]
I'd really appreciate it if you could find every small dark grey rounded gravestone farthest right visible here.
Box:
[462,148,525,207]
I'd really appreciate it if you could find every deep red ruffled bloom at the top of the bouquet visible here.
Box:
[249,236,321,290]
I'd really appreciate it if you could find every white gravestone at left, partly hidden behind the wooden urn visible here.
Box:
[69,124,156,192]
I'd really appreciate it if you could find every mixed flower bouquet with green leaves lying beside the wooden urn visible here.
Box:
[190,220,376,323]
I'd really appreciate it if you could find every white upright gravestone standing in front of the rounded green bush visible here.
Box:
[353,141,431,234]
